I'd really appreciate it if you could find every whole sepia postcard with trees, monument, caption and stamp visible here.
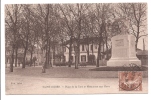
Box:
[2,2,148,95]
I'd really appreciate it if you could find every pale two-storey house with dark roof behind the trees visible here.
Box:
[63,37,106,64]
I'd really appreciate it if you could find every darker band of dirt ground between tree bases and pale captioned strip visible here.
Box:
[6,67,148,78]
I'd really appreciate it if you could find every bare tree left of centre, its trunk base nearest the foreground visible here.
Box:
[36,4,59,73]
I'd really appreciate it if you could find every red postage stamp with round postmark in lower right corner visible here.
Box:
[119,71,142,91]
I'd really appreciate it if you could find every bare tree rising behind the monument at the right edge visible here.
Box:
[116,3,148,49]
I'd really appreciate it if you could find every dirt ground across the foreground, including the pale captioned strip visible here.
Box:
[6,67,148,94]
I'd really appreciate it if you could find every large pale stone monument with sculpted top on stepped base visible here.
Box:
[107,19,141,67]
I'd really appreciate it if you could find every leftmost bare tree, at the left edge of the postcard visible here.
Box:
[5,4,21,72]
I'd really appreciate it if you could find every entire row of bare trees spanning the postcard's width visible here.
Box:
[5,3,147,72]
